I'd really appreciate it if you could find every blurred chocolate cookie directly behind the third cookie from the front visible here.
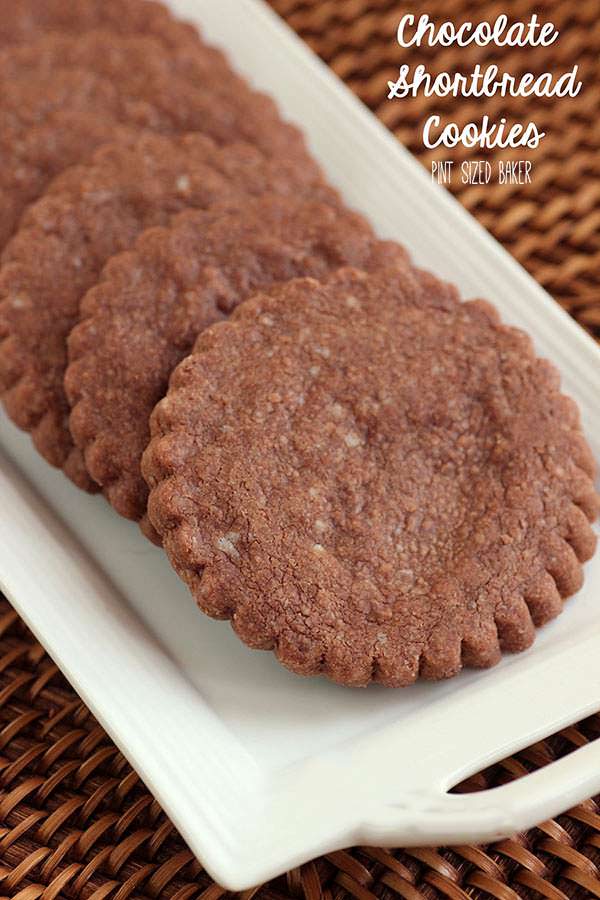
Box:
[0,31,308,247]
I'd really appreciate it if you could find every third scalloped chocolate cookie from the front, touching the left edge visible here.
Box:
[0,133,338,490]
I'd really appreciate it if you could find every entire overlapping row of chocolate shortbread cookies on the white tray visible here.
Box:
[0,0,599,686]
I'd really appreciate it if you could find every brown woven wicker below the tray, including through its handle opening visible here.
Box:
[0,600,600,900]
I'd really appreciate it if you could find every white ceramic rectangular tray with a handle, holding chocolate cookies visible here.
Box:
[0,0,600,889]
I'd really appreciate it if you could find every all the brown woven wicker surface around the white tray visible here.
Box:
[0,0,600,900]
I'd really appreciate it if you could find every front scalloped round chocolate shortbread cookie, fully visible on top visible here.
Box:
[143,271,599,686]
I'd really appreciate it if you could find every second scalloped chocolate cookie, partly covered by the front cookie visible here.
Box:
[65,195,407,536]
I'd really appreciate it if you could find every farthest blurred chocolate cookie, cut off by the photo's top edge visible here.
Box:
[0,0,198,50]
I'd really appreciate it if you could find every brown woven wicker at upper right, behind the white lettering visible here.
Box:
[271,0,600,337]
